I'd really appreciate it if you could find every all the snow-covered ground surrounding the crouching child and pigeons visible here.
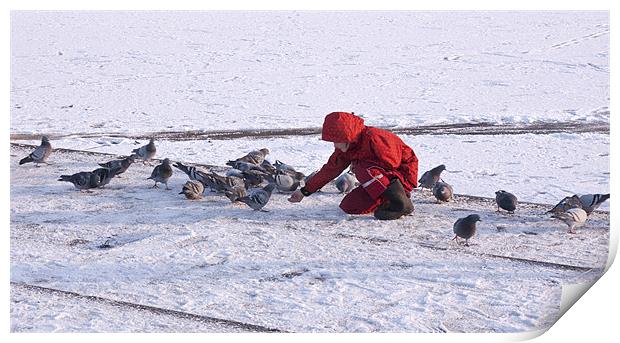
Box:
[10,12,610,332]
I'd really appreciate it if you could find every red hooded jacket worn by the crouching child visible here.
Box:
[304,112,418,193]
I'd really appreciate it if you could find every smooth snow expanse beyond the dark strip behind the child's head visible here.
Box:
[11,11,609,133]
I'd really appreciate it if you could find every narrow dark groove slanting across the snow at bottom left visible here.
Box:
[11,281,286,332]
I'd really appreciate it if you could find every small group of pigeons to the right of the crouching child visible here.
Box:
[418,164,609,245]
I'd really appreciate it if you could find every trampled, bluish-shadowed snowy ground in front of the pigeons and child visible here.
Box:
[11,148,609,332]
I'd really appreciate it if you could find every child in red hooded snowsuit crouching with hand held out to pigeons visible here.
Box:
[288,112,418,220]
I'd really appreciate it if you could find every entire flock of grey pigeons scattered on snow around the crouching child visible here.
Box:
[19,136,609,246]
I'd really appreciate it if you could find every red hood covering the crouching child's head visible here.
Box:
[322,112,366,143]
